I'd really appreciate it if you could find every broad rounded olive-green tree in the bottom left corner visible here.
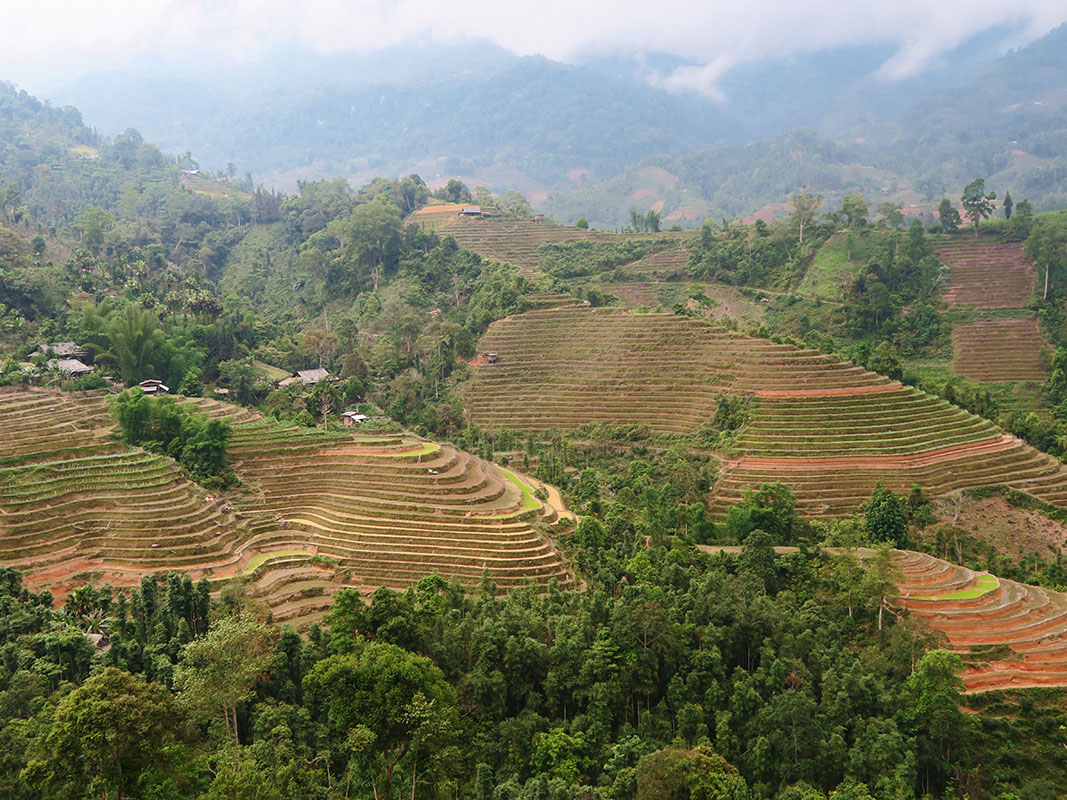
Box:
[23,667,180,800]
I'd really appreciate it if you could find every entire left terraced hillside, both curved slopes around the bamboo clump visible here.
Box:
[0,390,570,625]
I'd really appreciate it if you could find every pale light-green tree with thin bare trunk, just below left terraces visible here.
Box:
[174,614,276,745]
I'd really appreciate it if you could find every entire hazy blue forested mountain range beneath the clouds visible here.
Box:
[18,27,1067,226]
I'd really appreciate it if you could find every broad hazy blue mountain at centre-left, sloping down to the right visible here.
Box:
[48,53,743,190]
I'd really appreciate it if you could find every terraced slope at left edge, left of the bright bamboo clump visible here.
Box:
[0,390,241,575]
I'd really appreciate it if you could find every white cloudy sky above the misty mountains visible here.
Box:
[6,0,1067,94]
